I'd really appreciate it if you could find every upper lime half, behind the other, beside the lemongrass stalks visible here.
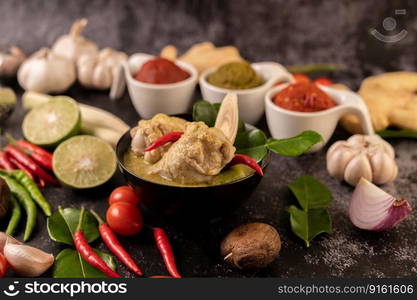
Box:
[22,97,81,147]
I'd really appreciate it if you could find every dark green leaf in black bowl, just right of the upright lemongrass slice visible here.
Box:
[235,129,268,162]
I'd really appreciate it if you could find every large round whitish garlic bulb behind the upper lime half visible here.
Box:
[17,48,76,93]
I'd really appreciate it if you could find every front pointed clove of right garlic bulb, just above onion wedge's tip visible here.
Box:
[344,153,373,186]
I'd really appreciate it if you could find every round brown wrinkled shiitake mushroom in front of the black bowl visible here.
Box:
[220,223,281,269]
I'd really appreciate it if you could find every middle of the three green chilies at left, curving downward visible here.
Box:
[0,173,37,241]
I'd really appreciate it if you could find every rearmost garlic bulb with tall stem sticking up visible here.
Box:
[52,19,98,62]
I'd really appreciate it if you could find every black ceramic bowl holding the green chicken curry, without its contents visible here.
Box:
[116,132,270,218]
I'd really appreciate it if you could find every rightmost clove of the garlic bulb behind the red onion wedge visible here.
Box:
[369,151,398,184]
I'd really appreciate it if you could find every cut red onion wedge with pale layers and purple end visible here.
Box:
[349,178,412,231]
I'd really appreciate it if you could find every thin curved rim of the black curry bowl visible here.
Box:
[116,129,271,189]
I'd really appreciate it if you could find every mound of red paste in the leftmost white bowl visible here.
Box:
[134,57,190,84]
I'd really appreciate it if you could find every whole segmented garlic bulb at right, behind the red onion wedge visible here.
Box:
[326,134,398,186]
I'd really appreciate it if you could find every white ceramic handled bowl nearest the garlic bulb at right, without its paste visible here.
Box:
[265,84,374,151]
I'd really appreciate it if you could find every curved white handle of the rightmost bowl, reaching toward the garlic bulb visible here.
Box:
[332,91,375,135]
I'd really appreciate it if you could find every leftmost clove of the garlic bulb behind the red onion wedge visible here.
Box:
[327,142,355,180]
